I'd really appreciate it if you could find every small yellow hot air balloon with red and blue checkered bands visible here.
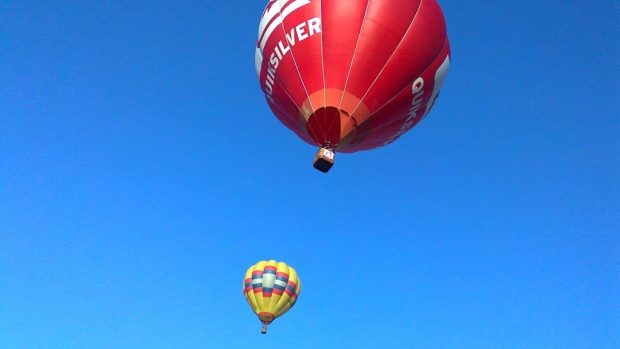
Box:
[243,260,301,334]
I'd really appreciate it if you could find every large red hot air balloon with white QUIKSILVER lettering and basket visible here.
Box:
[255,0,450,172]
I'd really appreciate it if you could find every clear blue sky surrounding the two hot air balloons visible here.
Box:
[0,0,620,349]
